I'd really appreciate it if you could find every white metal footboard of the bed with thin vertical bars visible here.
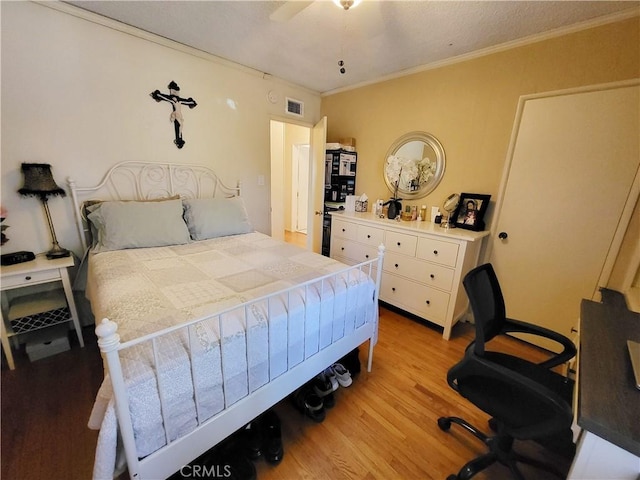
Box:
[96,245,384,479]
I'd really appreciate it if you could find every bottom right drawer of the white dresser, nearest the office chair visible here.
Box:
[380,273,449,326]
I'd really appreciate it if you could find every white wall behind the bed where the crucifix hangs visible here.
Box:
[0,2,320,254]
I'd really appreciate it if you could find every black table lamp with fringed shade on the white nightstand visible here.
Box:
[18,163,71,259]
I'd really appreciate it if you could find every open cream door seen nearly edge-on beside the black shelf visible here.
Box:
[307,117,327,253]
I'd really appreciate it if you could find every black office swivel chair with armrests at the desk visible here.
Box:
[438,264,576,480]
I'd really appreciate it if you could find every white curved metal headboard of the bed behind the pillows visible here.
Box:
[67,162,240,251]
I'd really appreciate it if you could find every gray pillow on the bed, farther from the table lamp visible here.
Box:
[182,197,253,240]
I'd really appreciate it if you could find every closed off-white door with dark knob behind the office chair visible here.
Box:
[490,84,640,348]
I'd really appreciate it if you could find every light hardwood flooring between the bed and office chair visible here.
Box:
[256,308,569,480]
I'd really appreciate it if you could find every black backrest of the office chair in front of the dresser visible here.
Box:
[462,263,506,356]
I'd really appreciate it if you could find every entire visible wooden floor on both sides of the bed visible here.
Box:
[1,308,568,480]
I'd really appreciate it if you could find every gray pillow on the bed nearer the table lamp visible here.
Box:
[87,200,190,251]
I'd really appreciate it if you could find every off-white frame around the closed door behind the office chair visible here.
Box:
[482,78,640,301]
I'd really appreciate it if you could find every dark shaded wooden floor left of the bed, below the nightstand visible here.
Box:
[0,328,102,480]
